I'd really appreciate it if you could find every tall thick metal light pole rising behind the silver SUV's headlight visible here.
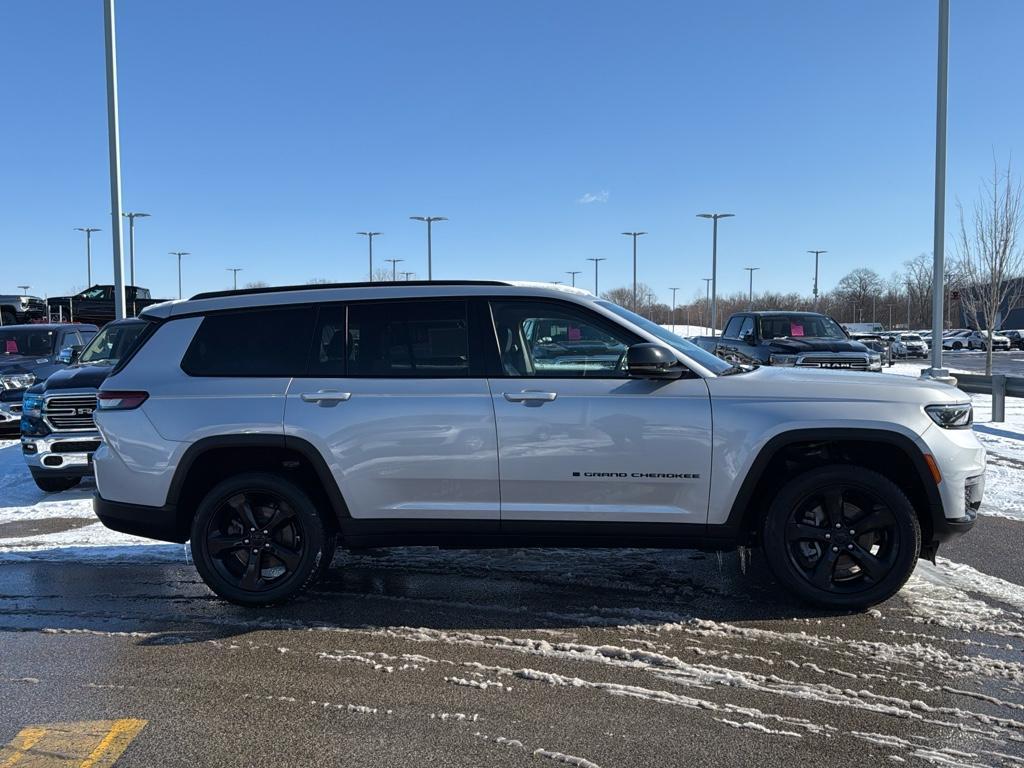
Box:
[921,0,949,380]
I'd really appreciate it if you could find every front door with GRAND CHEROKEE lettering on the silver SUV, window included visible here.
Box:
[489,300,712,527]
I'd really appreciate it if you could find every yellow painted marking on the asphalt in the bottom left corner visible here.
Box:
[0,718,146,768]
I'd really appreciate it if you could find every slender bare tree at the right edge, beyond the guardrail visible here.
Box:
[956,161,1024,375]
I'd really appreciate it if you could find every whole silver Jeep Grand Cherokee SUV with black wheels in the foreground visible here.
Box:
[95,282,985,607]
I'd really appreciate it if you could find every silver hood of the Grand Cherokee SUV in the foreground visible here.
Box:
[707,366,970,404]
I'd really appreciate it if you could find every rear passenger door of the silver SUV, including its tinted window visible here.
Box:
[285,299,499,529]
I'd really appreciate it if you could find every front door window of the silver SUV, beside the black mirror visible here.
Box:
[490,301,636,379]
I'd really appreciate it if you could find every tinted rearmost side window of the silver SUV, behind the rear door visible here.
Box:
[181,306,315,376]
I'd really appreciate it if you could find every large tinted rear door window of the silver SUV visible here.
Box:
[346,300,469,378]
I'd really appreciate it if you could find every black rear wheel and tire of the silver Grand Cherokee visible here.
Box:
[191,472,334,607]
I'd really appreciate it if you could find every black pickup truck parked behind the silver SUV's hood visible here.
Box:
[693,310,882,371]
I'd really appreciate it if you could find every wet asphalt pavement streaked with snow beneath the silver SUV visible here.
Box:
[0,517,1024,768]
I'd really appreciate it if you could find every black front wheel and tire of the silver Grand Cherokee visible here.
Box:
[763,464,921,608]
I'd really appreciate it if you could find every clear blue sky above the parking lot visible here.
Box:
[0,0,1024,303]
